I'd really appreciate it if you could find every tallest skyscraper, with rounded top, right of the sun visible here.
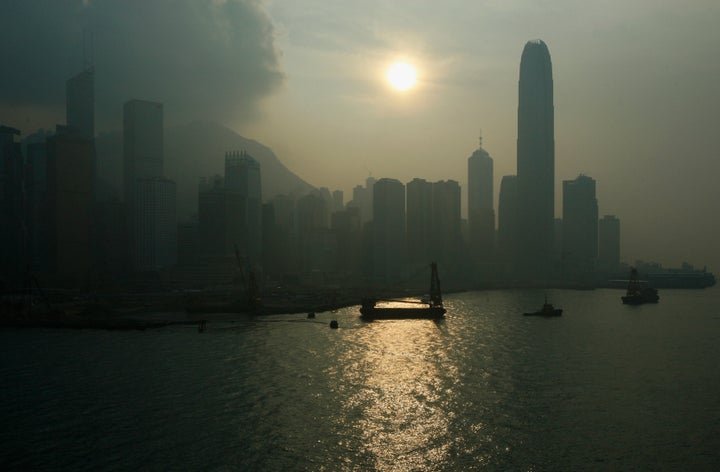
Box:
[516,40,556,277]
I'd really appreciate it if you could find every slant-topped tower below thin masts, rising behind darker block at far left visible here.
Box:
[65,68,95,139]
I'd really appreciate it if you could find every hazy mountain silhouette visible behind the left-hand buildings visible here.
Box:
[96,121,314,221]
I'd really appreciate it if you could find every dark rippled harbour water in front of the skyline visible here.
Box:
[0,288,720,471]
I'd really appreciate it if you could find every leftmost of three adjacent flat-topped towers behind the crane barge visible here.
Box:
[372,178,405,280]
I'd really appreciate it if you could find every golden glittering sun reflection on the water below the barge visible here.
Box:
[340,320,453,470]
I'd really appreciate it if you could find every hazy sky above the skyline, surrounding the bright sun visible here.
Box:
[0,0,720,272]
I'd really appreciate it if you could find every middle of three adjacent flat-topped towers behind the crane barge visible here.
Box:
[407,179,433,264]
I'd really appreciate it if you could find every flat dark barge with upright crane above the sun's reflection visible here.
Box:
[360,262,446,320]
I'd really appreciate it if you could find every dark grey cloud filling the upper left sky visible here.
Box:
[0,0,283,129]
